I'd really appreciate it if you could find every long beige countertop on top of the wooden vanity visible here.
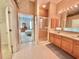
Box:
[49,29,79,40]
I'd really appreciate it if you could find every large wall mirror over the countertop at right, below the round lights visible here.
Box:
[59,4,79,32]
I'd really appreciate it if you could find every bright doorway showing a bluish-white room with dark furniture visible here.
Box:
[18,13,34,44]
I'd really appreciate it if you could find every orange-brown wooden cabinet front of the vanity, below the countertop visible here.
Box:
[49,33,79,59]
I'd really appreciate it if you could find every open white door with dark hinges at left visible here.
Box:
[6,6,19,52]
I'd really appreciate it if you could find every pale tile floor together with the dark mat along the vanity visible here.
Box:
[12,43,74,59]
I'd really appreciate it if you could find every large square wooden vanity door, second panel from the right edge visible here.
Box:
[61,37,73,55]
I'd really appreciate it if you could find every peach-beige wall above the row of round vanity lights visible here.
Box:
[57,0,79,12]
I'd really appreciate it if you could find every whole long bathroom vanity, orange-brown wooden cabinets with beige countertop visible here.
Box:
[49,31,79,59]
